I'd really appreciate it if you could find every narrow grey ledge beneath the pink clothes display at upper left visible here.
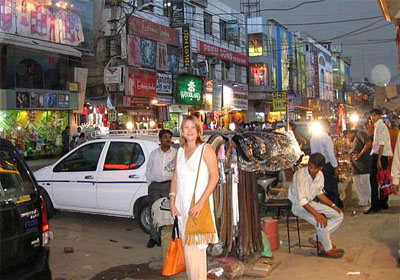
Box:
[0,33,82,57]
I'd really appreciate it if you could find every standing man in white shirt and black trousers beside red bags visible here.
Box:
[364,109,393,214]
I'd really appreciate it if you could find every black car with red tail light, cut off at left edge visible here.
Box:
[0,137,51,280]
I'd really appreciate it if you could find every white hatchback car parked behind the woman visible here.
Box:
[34,138,158,232]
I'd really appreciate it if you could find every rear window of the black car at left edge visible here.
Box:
[0,151,35,206]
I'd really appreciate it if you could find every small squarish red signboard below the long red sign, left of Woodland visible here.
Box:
[125,68,157,96]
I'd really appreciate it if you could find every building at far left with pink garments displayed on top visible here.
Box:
[0,0,99,156]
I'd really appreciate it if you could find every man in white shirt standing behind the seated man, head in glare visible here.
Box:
[310,121,341,205]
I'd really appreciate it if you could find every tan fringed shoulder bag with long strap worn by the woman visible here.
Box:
[185,145,216,245]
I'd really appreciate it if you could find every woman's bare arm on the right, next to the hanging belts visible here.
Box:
[189,145,219,217]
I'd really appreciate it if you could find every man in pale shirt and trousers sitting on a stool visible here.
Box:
[289,153,344,258]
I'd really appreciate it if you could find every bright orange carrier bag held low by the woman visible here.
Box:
[162,217,186,276]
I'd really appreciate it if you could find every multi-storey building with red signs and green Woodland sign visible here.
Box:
[89,0,248,131]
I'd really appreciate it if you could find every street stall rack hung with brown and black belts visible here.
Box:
[208,131,301,262]
